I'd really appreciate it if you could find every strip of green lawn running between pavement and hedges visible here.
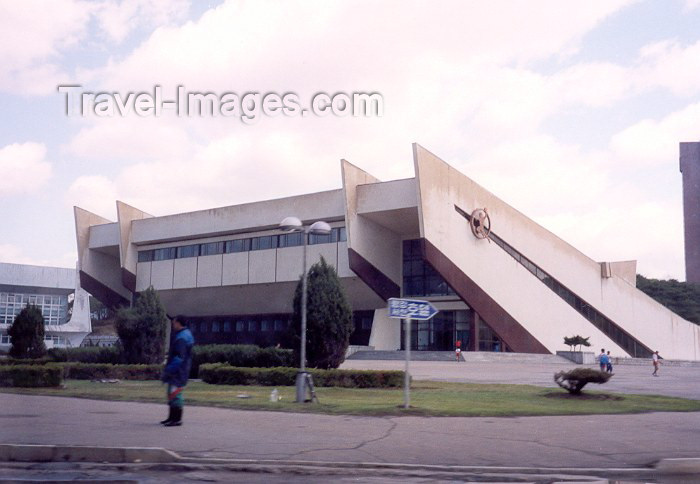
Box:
[0,380,700,417]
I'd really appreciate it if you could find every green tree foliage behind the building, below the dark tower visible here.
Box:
[637,274,700,325]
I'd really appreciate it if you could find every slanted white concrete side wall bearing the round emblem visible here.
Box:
[414,145,698,359]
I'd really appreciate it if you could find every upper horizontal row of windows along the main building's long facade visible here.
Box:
[138,227,347,262]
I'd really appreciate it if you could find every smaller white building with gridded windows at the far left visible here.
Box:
[0,263,91,351]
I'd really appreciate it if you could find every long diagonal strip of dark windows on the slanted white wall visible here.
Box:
[455,205,652,358]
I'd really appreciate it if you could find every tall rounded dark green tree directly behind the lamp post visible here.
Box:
[291,257,354,369]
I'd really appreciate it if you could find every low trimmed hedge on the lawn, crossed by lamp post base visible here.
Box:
[199,363,404,388]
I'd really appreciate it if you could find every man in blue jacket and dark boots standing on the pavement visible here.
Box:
[161,315,194,427]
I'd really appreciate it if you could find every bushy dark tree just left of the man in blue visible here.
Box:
[116,287,168,364]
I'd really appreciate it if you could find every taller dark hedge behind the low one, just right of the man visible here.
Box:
[190,345,296,378]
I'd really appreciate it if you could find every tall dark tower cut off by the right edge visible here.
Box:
[680,142,700,284]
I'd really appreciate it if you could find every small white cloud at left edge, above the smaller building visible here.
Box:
[0,143,51,197]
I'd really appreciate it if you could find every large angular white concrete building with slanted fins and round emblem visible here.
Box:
[75,145,700,360]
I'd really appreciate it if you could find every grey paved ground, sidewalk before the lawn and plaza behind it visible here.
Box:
[0,361,700,480]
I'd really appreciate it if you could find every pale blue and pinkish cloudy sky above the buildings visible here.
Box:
[0,0,700,280]
